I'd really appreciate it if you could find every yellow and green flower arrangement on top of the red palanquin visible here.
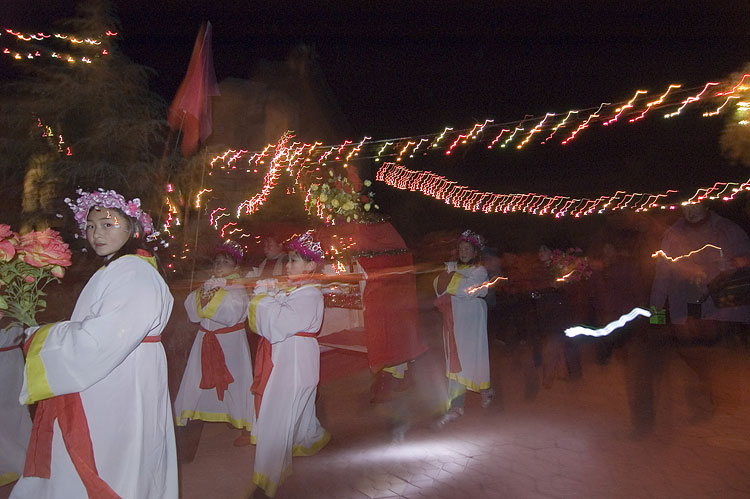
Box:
[305,170,380,223]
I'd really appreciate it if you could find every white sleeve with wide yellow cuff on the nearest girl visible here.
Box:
[20,256,173,404]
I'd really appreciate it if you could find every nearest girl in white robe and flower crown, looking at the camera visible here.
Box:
[10,191,178,499]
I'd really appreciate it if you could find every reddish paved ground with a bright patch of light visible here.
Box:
[0,311,750,499]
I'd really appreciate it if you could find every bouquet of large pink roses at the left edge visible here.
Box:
[0,224,71,326]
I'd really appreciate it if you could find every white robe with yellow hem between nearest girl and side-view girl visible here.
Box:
[174,287,255,430]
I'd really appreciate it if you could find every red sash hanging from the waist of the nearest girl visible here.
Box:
[23,335,161,499]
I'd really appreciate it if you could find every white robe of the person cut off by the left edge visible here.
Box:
[0,326,31,487]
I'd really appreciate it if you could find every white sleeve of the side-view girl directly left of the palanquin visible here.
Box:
[248,286,323,343]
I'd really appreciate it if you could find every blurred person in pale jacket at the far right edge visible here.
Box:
[650,203,750,421]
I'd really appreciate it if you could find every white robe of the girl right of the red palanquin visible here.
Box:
[435,265,490,392]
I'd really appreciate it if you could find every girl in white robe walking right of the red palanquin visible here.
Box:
[434,230,494,424]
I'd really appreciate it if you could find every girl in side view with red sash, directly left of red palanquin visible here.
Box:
[248,232,330,497]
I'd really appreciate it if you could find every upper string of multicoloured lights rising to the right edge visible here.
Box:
[197,74,750,182]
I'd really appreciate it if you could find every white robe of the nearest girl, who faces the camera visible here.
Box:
[11,255,178,499]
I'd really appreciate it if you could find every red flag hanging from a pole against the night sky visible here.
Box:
[167,22,220,157]
